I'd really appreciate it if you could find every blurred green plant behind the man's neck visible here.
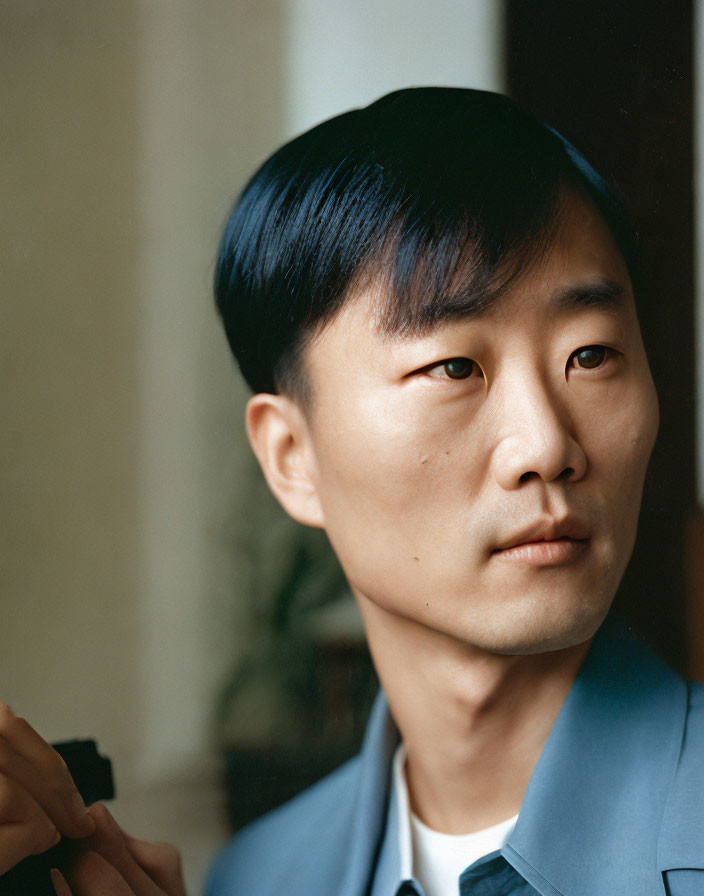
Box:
[215,460,353,748]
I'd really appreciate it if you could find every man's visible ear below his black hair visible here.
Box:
[245,392,324,529]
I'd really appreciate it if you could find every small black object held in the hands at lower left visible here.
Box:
[0,740,115,896]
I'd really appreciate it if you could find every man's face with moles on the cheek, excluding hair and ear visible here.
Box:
[298,196,658,653]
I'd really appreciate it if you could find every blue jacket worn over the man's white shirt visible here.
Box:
[206,622,704,896]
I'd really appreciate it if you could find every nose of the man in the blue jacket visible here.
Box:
[493,379,587,490]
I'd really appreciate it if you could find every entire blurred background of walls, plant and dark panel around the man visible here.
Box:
[0,0,704,894]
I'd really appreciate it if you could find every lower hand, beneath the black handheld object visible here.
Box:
[51,803,186,896]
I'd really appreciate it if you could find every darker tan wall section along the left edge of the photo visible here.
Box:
[0,2,143,761]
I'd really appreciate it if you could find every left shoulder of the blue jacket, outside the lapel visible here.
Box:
[205,756,360,896]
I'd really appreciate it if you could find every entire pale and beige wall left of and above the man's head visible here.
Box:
[0,0,500,893]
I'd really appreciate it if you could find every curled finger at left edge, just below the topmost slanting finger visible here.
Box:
[0,777,60,874]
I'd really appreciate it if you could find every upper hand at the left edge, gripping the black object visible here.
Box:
[0,703,95,874]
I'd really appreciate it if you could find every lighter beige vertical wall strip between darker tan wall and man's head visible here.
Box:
[132,0,284,777]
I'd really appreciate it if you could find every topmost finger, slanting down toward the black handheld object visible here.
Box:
[0,703,94,837]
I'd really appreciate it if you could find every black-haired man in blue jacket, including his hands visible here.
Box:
[0,88,704,896]
